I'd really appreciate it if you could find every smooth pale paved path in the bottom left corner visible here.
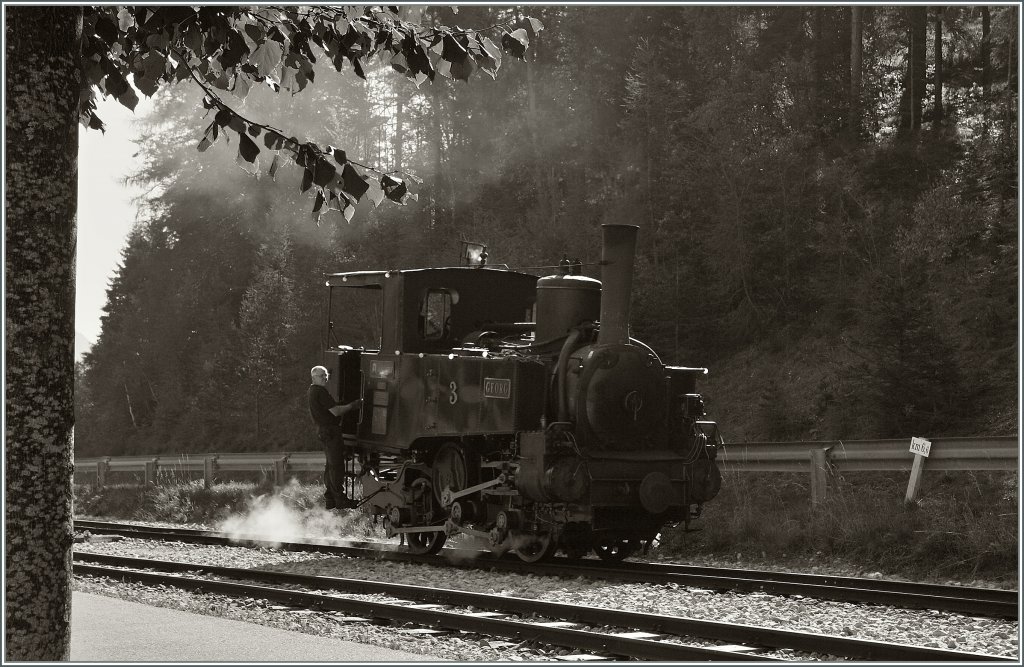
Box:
[71,591,437,663]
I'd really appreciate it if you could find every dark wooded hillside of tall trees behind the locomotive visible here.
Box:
[75,5,1019,457]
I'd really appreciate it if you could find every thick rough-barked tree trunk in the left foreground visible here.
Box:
[4,6,83,661]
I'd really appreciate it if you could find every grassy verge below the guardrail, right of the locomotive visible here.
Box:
[659,472,1019,583]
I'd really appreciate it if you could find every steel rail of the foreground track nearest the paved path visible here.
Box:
[74,564,774,662]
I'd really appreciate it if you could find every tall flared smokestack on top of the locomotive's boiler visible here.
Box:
[597,224,640,345]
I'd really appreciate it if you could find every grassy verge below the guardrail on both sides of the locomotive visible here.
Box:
[75,472,1019,585]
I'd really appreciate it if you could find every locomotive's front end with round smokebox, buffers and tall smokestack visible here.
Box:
[517,224,721,558]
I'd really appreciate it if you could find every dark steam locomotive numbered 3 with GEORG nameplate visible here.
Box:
[326,224,721,562]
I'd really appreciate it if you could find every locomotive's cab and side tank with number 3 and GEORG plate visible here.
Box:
[327,267,543,453]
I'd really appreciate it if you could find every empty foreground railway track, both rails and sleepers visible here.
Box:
[74,553,1015,662]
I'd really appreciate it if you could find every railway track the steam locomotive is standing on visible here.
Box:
[75,520,1019,619]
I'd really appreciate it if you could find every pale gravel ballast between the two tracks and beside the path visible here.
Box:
[75,538,1019,661]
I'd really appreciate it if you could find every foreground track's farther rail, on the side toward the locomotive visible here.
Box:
[75,553,1010,661]
